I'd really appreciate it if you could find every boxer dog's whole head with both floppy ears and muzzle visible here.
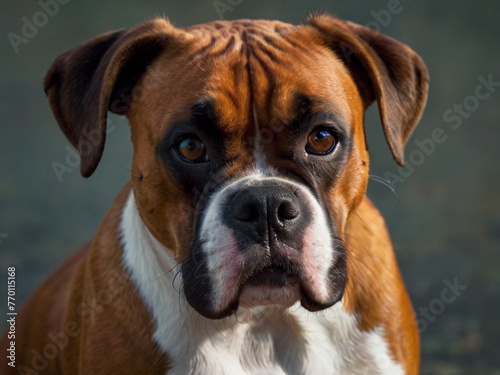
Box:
[45,15,427,318]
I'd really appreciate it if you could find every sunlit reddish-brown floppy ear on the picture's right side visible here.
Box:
[307,15,429,166]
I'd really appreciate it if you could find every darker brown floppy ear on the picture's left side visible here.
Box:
[44,19,181,177]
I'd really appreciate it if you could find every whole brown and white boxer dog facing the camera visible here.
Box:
[2,15,428,375]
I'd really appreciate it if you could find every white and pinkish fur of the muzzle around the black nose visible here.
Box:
[198,174,337,316]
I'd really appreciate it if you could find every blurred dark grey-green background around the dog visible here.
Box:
[0,0,500,374]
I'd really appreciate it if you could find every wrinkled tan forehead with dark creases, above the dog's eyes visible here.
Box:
[135,21,360,138]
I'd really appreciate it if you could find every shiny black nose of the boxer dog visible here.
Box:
[228,185,302,240]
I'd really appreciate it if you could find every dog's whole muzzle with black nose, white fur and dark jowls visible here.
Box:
[182,176,346,319]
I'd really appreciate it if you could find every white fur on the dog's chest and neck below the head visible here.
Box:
[121,193,404,375]
